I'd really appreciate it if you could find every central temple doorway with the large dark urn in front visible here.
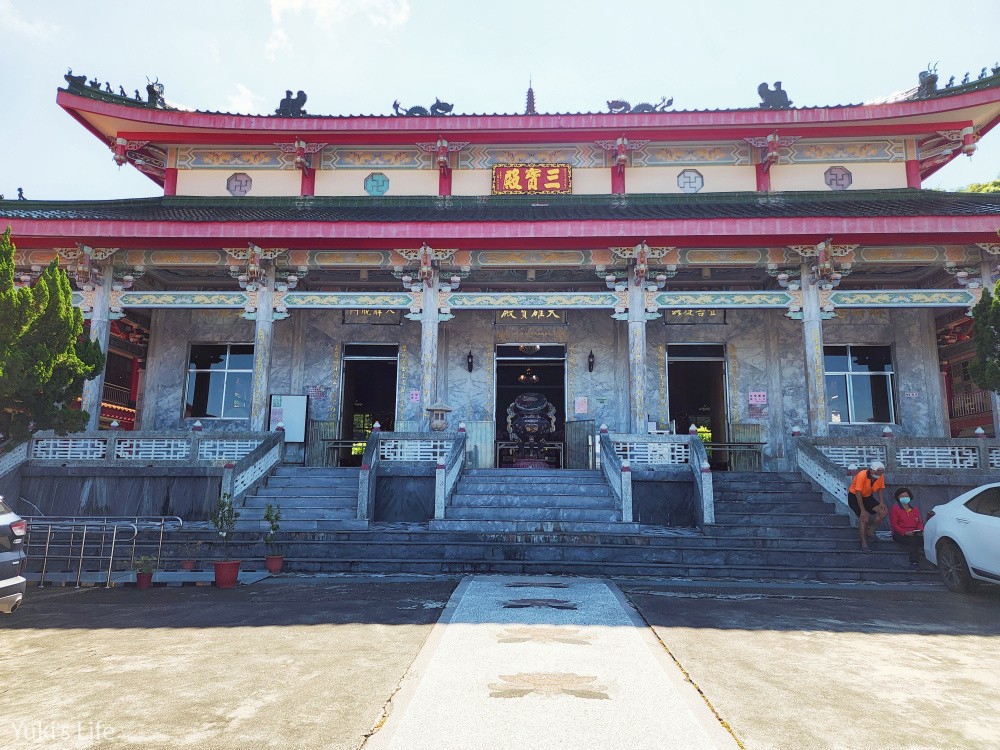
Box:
[494,343,566,469]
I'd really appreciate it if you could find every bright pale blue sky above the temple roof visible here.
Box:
[0,0,1000,199]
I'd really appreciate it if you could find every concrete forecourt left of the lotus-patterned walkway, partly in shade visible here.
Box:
[0,578,458,750]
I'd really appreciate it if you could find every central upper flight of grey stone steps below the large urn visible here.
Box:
[430,469,639,533]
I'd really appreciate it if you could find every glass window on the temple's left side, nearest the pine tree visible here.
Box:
[184,344,253,419]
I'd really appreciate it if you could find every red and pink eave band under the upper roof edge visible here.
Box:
[56,89,1000,145]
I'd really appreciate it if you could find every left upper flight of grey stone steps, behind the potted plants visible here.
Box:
[236,466,367,533]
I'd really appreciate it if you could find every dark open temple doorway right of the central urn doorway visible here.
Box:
[667,344,728,466]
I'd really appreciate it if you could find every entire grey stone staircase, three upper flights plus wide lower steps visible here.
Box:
[201,468,934,582]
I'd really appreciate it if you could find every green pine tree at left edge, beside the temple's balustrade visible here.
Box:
[0,227,104,443]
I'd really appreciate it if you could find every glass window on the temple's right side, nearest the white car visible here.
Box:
[823,346,895,423]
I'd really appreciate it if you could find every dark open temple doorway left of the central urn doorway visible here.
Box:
[336,344,399,466]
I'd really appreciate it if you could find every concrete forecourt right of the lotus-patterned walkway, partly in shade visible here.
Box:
[619,582,1000,750]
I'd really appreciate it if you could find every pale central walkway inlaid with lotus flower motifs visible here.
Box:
[365,576,737,750]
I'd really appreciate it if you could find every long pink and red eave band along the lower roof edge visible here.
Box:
[4,216,996,251]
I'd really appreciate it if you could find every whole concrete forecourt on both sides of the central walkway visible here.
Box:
[0,577,1000,750]
